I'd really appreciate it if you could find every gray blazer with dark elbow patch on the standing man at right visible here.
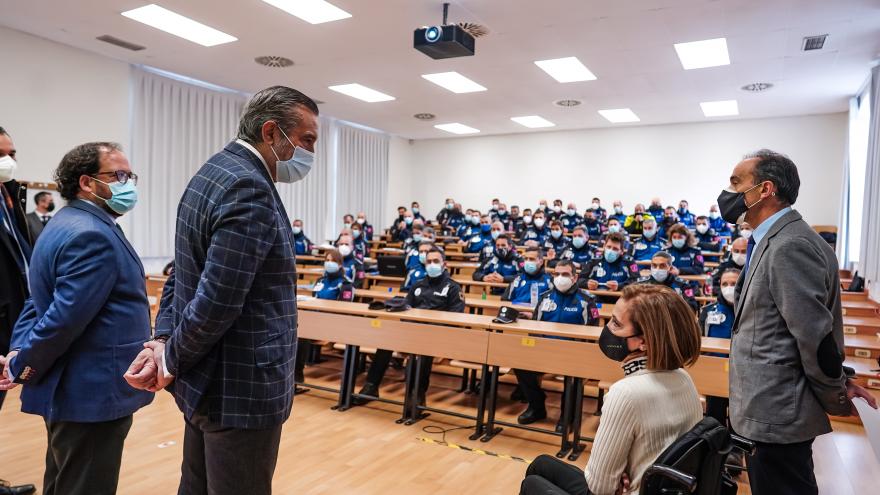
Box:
[730,210,850,444]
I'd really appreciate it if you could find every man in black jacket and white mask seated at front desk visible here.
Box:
[354,246,464,405]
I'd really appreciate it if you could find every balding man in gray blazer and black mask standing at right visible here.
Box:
[718,150,877,495]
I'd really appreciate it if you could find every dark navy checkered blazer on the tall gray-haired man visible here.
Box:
[156,142,297,429]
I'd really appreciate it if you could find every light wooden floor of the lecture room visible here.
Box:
[0,358,880,495]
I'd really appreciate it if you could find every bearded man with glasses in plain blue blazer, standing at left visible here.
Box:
[0,143,153,495]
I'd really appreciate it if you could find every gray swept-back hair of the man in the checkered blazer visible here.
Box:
[238,86,318,144]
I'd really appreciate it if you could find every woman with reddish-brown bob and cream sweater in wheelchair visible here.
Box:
[520,284,703,495]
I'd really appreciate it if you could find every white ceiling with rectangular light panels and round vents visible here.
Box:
[0,0,880,139]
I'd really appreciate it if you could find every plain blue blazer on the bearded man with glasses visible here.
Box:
[10,200,153,423]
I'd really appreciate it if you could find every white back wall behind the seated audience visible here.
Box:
[398,113,847,224]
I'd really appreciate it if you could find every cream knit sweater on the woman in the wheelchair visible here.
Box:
[584,369,703,495]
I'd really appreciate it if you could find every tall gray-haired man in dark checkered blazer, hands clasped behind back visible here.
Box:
[124,86,318,495]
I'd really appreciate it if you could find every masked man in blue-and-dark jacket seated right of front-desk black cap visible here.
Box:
[513,260,599,431]
